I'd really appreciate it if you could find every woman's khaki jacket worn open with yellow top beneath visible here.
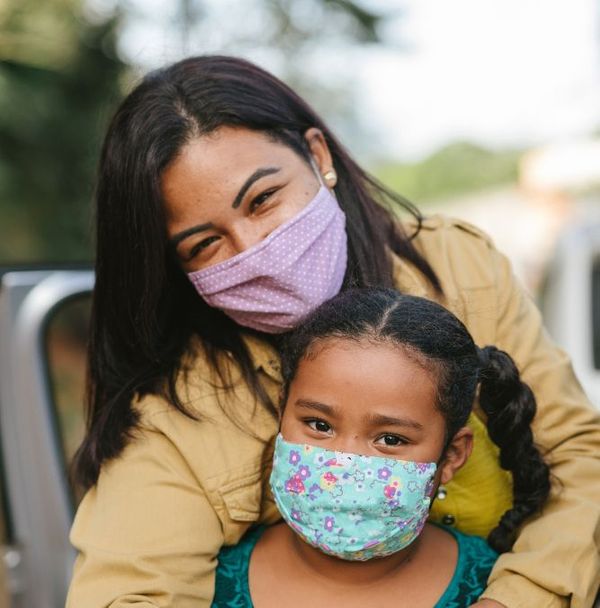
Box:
[67,217,600,608]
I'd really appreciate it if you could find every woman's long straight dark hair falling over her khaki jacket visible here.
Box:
[75,56,441,488]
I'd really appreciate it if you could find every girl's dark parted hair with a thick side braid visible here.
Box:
[282,289,550,553]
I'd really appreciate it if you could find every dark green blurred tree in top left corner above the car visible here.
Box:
[0,0,126,262]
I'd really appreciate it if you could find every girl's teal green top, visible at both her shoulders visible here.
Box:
[212,526,498,608]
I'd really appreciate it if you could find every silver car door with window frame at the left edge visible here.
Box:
[0,268,94,608]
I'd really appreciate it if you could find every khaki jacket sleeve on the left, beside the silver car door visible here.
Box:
[67,420,223,608]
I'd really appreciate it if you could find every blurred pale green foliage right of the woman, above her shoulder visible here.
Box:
[371,142,522,205]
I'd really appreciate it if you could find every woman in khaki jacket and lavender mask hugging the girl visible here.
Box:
[68,57,600,608]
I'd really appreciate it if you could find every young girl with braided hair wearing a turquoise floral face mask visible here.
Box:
[213,289,550,608]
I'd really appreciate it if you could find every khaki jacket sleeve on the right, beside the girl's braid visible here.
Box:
[483,243,600,608]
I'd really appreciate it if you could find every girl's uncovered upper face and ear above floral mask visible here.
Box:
[281,338,472,483]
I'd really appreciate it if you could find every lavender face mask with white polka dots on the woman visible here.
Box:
[188,186,348,333]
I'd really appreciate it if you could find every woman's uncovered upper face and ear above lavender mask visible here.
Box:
[161,127,335,272]
